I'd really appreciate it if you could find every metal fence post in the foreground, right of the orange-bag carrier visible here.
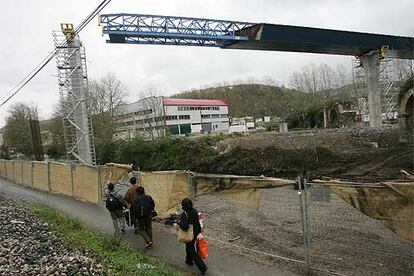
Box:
[298,176,311,274]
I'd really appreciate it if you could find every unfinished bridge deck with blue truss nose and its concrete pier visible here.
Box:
[100,13,414,127]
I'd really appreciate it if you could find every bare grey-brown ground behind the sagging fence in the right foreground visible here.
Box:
[195,187,414,275]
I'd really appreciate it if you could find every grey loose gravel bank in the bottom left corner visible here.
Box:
[0,195,108,275]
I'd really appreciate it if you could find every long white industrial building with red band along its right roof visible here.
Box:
[115,97,229,139]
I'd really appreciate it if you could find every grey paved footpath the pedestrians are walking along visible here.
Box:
[0,178,295,276]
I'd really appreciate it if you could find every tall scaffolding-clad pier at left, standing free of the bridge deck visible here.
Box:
[53,24,96,165]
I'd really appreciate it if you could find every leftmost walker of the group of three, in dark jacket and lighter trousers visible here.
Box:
[105,183,125,235]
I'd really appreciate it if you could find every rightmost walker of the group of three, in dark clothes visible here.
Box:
[132,186,156,248]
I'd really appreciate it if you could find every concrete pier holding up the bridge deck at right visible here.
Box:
[362,52,381,127]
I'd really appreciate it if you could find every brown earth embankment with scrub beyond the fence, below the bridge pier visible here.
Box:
[209,128,414,182]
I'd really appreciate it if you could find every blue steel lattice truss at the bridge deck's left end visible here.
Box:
[100,13,255,47]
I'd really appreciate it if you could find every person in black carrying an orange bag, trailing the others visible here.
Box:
[178,198,207,275]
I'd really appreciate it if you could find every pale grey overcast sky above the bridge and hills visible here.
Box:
[0,0,414,127]
